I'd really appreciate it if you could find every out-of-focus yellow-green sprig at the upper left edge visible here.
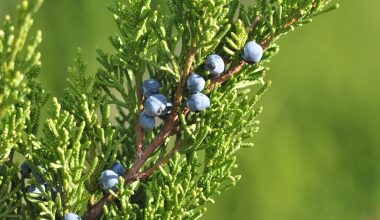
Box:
[0,0,42,117]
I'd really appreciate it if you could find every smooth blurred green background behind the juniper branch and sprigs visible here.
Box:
[0,0,380,220]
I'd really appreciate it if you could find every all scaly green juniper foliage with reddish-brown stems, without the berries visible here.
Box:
[0,0,338,219]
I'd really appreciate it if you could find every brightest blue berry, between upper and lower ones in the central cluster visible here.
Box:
[144,94,168,117]
